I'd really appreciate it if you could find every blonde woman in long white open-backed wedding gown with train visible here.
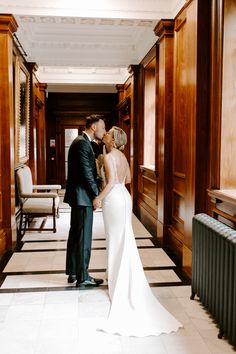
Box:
[94,127,182,337]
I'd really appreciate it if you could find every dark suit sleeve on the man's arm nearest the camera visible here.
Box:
[78,140,99,197]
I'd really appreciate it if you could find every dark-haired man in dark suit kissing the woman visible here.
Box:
[64,114,106,289]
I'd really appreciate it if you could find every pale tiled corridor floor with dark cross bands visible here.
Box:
[0,205,234,354]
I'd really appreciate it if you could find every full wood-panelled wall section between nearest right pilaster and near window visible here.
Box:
[168,1,210,273]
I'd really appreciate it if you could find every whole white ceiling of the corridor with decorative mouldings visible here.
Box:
[0,0,185,92]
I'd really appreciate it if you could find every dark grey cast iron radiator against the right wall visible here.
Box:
[191,214,236,346]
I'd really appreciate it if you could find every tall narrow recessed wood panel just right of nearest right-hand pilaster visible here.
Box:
[170,12,189,245]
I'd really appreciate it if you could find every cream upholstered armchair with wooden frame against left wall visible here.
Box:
[16,165,61,236]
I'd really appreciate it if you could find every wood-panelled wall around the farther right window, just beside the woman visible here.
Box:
[117,62,157,235]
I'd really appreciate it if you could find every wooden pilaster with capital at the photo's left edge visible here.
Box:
[0,15,17,254]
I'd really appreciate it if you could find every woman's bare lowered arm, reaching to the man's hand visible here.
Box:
[93,154,115,209]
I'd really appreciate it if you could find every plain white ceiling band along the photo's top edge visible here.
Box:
[1,0,174,20]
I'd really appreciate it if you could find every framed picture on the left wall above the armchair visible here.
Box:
[15,57,30,163]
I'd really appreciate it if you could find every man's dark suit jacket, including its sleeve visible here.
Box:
[64,134,99,206]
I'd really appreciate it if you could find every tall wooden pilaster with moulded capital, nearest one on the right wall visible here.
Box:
[154,20,174,244]
